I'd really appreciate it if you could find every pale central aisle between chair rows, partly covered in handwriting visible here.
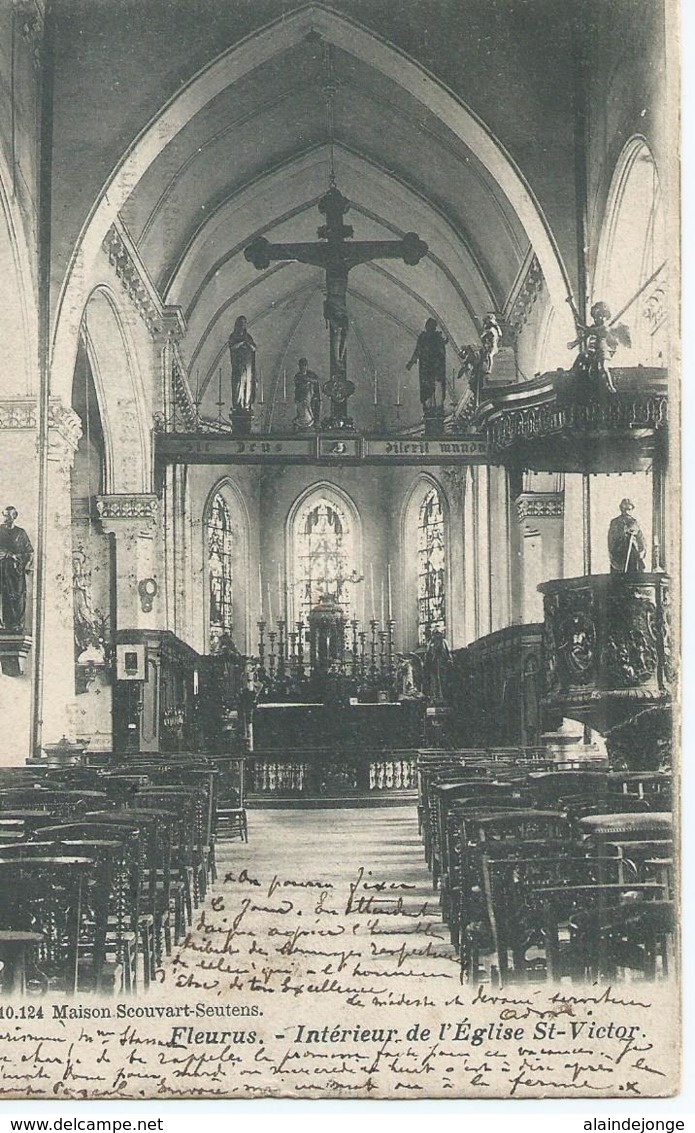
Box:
[173,807,459,1008]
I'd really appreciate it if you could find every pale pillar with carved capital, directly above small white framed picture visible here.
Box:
[96,492,159,631]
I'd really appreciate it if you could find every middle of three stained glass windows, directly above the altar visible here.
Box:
[294,496,355,621]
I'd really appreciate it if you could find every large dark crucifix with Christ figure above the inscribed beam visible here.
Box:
[244,184,429,428]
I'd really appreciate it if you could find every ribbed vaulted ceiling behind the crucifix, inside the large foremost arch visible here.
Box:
[50,3,580,426]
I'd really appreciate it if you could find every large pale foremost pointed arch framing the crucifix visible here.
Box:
[52,3,571,403]
